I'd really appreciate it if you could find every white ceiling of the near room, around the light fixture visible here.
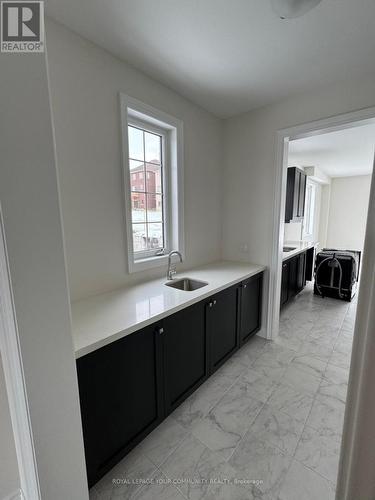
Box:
[46,0,375,117]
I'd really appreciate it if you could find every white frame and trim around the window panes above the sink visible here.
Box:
[120,92,185,273]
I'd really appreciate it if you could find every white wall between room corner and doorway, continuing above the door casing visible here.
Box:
[223,71,375,328]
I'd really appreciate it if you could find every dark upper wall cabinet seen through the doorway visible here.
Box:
[285,167,306,222]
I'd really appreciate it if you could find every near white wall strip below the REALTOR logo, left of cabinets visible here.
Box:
[0,49,88,500]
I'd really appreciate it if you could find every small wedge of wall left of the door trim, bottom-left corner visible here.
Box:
[0,356,20,498]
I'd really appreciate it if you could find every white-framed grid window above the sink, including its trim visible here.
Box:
[120,94,183,272]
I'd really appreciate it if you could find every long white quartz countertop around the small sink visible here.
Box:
[72,261,265,358]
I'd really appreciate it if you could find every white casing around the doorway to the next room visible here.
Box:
[267,107,375,339]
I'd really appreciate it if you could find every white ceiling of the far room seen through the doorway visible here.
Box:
[288,124,375,177]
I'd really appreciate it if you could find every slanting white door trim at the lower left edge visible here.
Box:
[0,206,41,500]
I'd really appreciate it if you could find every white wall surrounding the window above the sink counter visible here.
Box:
[47,21,223,299]
